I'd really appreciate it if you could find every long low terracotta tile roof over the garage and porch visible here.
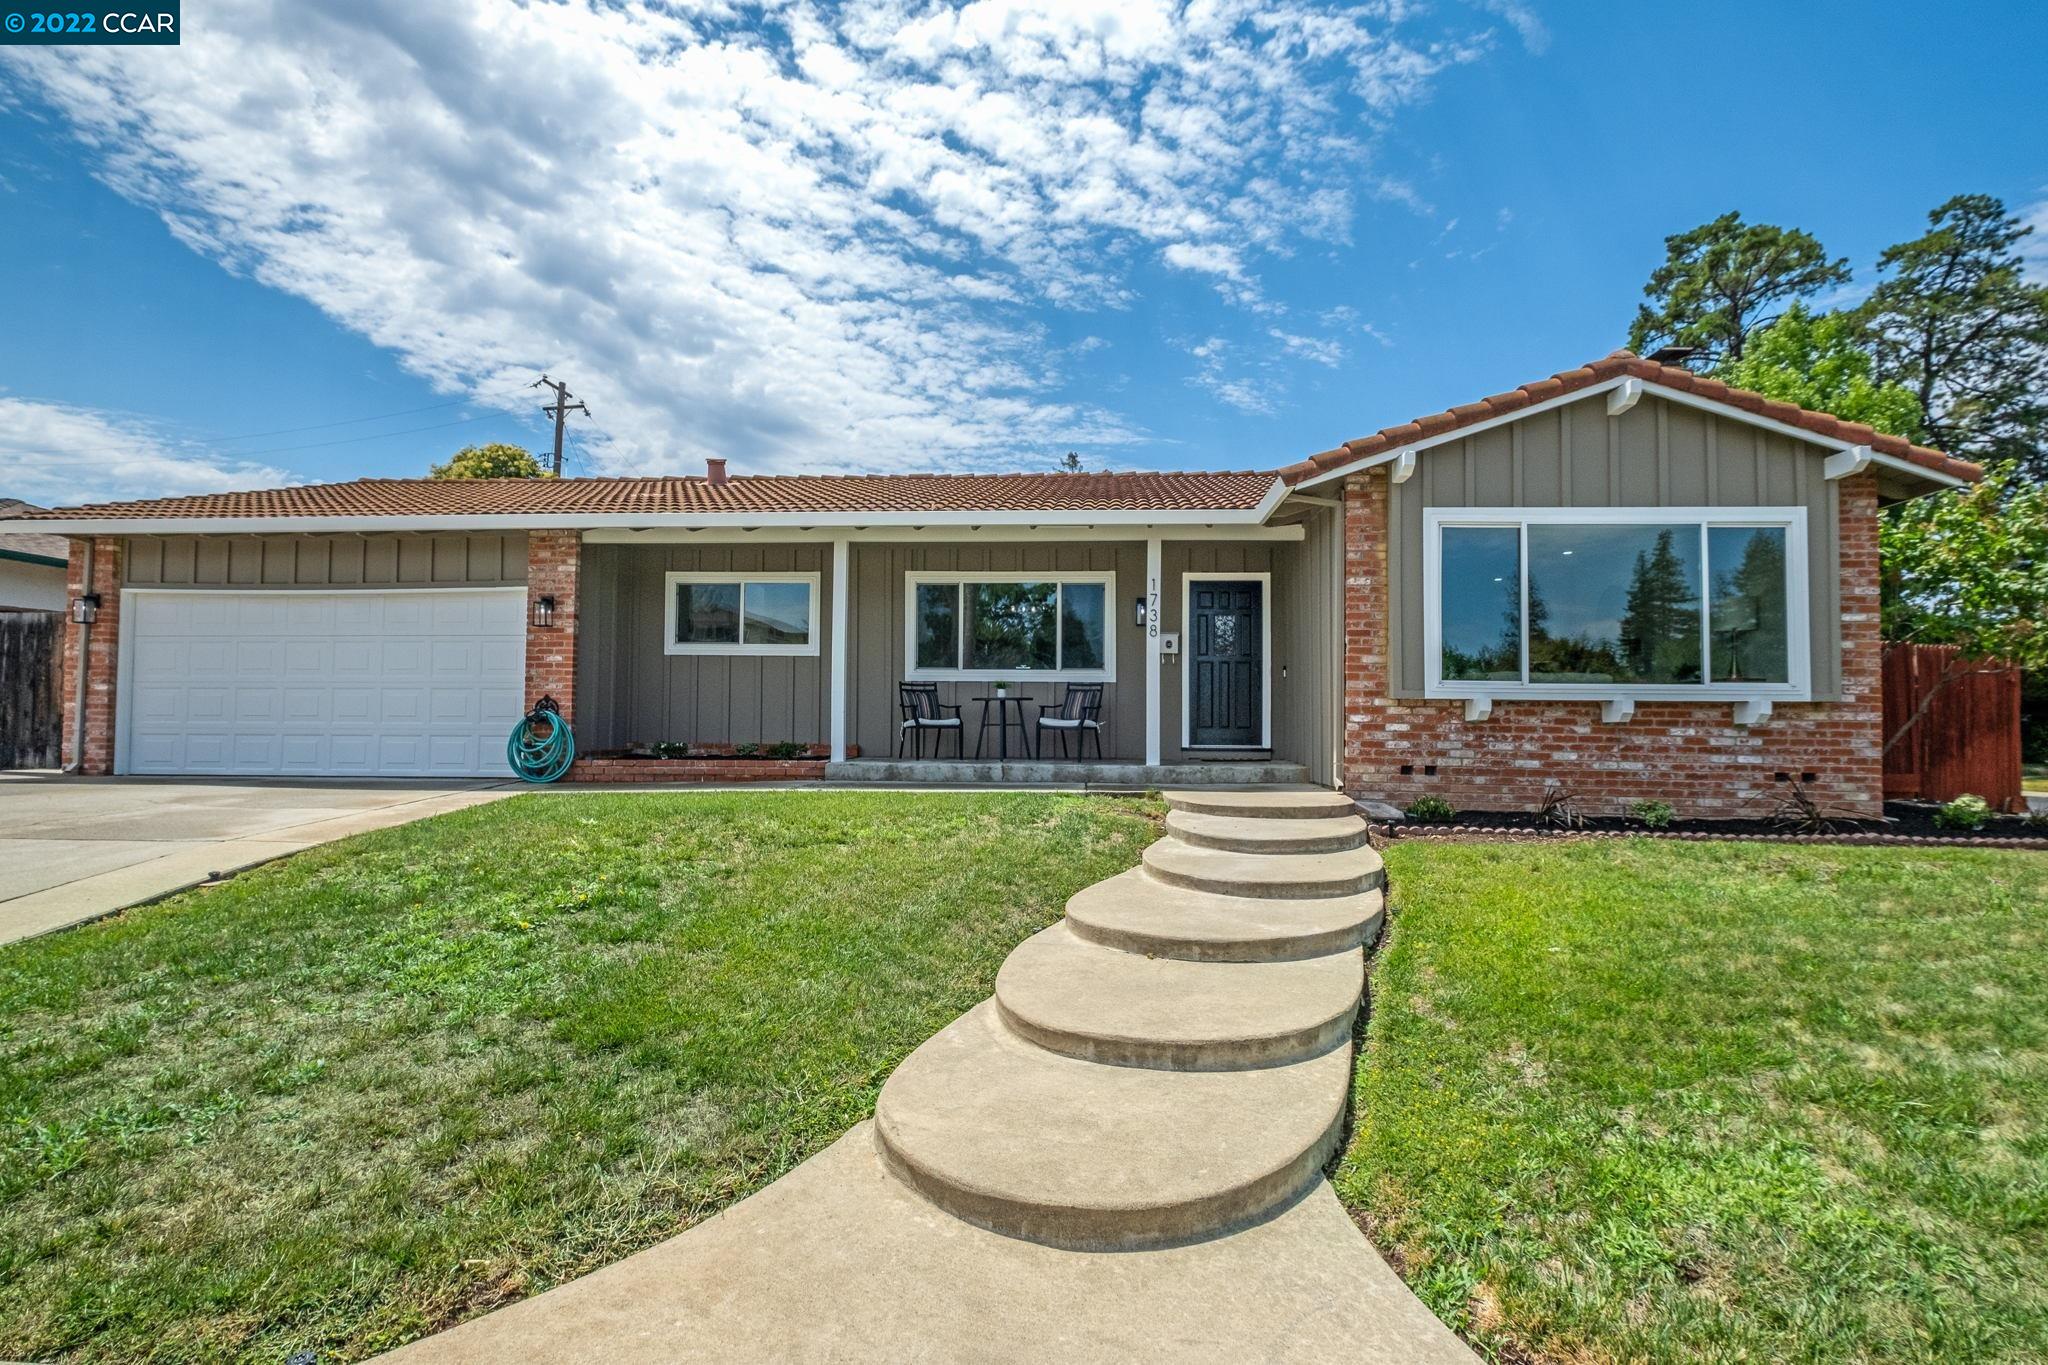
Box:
[33,473,1274,520]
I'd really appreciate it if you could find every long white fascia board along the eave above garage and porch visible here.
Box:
[25,497,1286,536]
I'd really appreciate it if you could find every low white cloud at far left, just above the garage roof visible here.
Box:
[0,397,291,508]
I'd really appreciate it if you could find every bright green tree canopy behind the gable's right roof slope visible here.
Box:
[1714,303,1923,440]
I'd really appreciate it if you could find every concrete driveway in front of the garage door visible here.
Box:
[0,774,522,943]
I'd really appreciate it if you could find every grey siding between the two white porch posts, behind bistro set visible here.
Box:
[846,540,1145,763]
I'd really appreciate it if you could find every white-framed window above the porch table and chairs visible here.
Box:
[903,573,1116,681]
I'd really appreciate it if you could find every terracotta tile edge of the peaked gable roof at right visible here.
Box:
[1280,350,1985,483]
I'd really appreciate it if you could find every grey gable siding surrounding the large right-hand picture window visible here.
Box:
[1386,395,1841,700]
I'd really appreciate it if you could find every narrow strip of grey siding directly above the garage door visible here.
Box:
[121,532,526,589]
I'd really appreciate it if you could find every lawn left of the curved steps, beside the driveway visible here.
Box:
[0,792,1157,1361]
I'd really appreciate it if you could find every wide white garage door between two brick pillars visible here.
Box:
[115,589,526,778]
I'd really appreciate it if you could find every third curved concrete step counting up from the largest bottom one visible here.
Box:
[1067,868,1386,962]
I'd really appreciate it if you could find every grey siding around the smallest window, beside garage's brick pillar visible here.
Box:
[575,542,831,751]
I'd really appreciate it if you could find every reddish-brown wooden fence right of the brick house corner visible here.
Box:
[1884,645,2025,810]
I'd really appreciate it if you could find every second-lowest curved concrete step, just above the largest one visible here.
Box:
[995,925,1366,1070]
